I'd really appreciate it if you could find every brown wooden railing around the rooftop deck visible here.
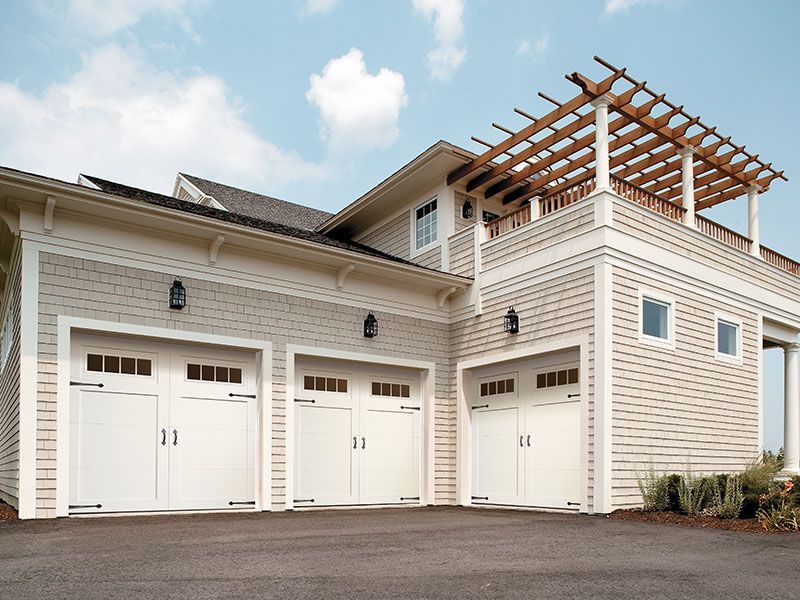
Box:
[486,174,800,276]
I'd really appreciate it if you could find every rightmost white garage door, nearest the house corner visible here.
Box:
[471,367,580,509]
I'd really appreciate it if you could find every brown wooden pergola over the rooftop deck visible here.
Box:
[447,57,786,213]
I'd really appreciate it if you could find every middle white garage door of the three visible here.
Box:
[294,361,421,507]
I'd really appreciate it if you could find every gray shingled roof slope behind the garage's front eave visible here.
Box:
[181,173,333,230]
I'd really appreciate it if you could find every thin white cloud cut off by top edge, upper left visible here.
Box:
[67,0,204,38]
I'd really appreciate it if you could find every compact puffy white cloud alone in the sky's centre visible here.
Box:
[306,48,408,156]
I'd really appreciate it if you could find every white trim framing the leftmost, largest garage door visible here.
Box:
[55,316,272,517]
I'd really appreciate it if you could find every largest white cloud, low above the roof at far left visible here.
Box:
[0,45,326,193]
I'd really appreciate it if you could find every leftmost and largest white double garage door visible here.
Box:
[69,335,256,513]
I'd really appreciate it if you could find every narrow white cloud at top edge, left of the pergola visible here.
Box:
[412,0,467,81]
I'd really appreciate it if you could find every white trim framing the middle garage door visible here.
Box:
[284,344,436,510]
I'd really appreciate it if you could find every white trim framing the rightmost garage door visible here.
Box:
[456,335,590,512]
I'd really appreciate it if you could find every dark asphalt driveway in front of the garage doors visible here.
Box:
[0,508,800,600]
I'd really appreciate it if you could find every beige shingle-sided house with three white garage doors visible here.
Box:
[0,62,800,518]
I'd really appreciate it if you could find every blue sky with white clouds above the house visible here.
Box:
[0,0,800,448]
